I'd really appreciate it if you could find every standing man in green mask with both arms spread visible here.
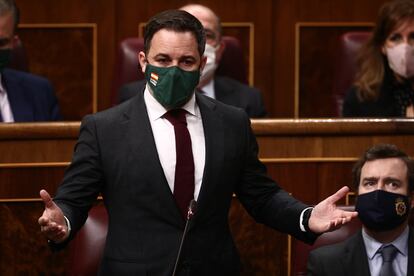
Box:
[39,10,356,276]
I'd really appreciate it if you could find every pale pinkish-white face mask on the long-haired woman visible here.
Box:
[385,43,414,78]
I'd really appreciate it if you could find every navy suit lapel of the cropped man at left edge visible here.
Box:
[2,69,34,122]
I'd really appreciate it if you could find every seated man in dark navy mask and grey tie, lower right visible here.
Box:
[308,145,414,276]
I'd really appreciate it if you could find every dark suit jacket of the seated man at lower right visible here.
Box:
[308,228,414,276]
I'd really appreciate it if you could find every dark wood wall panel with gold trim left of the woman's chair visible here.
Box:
[295,22,372,118]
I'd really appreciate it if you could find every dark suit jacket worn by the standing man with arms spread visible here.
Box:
[54,93,314,276]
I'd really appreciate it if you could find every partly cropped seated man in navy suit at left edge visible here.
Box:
[0,0,62,123]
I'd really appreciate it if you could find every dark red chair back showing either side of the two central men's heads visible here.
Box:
[112,36,247,104]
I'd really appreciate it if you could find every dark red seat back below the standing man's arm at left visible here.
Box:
[66,204,108,276]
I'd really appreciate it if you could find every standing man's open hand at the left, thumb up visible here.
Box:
[38,190,69,243]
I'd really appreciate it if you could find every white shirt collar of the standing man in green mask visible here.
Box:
[144,84,200,121]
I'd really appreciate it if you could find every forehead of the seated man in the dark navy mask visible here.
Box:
[361,158,408,182]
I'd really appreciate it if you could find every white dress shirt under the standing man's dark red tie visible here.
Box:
[144,86,206,200]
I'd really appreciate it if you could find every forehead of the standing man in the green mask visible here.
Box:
[148,29,200,59]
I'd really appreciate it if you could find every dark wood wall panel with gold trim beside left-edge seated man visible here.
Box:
[19,24,97,121]
